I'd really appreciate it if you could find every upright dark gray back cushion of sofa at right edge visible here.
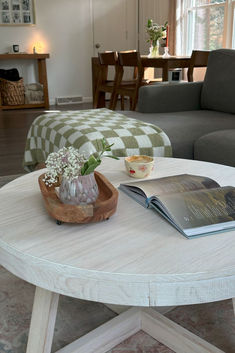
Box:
[201,49,235,113]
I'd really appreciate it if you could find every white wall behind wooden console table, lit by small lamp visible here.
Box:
[0,0,93,103]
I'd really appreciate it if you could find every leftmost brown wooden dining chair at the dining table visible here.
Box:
[93,51,118,109]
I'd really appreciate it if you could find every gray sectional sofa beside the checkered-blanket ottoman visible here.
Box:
[124,49,235,166]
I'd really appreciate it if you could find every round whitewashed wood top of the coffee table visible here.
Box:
[0,158,235,306]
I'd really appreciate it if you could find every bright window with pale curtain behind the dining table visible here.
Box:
[177,0,235,55]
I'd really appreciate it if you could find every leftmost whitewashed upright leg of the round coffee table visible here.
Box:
[26,287,59,353]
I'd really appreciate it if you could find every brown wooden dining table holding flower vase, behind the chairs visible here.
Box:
[91,55,191,108]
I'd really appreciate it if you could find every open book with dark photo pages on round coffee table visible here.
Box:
[119,174,235,238]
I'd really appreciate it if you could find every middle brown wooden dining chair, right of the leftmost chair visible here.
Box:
[111,50,145,110]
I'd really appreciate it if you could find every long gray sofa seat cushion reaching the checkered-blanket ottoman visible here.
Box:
[122,110,235,159]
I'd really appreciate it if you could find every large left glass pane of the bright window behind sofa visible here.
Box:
[187,4,224,54]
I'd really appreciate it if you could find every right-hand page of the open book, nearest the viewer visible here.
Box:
[158,186,235,231]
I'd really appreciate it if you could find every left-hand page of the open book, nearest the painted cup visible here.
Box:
[121,174,219,198]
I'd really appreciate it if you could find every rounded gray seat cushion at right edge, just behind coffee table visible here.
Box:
[194,129,235,167]
